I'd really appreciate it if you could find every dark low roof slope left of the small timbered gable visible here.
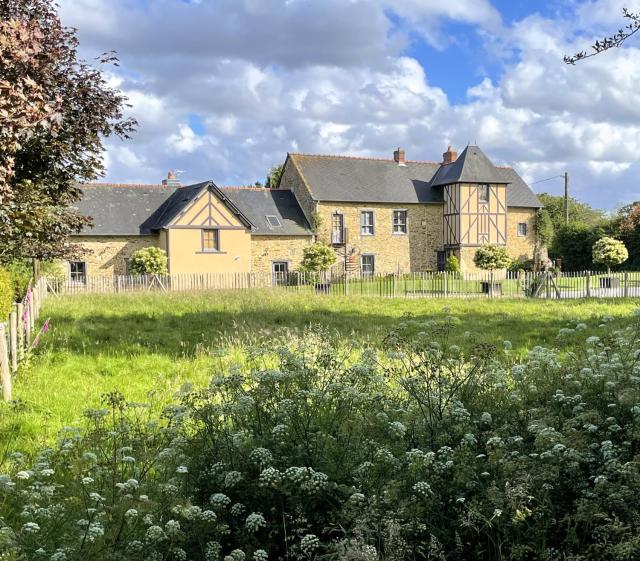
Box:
[75,183,176,236]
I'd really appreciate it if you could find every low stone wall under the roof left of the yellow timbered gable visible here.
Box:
[72,236,158,277]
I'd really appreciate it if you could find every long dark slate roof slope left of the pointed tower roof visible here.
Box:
[289,154,443,203]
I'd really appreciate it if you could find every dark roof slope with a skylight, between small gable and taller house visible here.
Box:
[221,187,313,236]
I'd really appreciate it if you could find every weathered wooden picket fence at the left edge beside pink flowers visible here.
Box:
[0,279,49,401]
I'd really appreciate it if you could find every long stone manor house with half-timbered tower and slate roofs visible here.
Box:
[68,146,541,281]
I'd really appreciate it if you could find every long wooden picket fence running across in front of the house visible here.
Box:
[44,271,640,299]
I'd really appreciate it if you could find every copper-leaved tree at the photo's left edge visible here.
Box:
[0,0,136,262]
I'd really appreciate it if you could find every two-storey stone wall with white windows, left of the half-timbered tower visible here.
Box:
[317,202,443,273]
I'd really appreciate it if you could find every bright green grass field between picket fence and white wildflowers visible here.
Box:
[0,291,640,459]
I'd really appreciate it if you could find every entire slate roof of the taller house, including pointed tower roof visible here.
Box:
[289,146,542,208]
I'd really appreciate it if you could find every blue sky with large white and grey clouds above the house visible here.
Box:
[61,0,640,210]
